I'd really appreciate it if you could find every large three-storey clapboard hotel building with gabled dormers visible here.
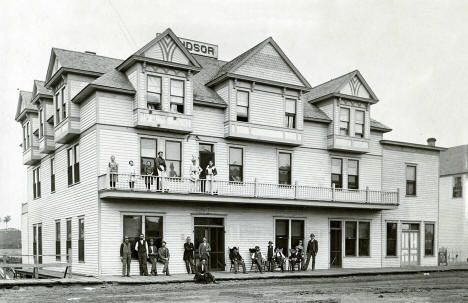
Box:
[16,29,444,276]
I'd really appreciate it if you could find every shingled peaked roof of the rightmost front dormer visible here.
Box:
[305,70,379,102]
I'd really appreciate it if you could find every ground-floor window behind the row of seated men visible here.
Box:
[275,219,304,256]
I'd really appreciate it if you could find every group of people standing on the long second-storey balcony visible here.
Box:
[108,151,218,193]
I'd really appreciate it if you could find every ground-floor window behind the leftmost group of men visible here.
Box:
[122,215,163,259]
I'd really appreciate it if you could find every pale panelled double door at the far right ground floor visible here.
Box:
[401,223,419,265]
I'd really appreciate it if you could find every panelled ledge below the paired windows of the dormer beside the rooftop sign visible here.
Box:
[133,108,192,134]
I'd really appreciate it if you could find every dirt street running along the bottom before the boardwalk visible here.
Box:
[0,272,468,303]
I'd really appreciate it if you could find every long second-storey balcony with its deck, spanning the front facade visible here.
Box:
[98,174,399,210]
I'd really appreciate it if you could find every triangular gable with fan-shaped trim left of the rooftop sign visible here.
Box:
[143,35,190,65]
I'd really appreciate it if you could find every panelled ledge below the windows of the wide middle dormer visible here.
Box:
[224,121,302,146]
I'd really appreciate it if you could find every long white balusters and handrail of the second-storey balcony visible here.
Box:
[99,174,399,205]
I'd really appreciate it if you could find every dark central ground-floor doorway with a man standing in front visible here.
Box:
[194,217,226,271]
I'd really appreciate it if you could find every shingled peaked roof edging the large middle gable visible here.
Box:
[209,37,310,88]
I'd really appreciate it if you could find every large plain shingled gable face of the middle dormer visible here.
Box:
[233,42,304,86]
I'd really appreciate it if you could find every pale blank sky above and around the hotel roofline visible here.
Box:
[0,0,468,228]
